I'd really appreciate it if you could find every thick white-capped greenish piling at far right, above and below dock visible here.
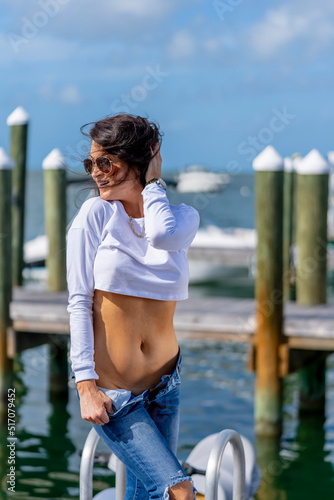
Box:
[296,149,329,413]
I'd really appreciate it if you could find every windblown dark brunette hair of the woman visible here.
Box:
[80,114,163,187]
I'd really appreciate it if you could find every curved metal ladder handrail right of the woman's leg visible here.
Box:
[205,429,246,500]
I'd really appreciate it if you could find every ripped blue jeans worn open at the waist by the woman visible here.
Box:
[78,353,196,500]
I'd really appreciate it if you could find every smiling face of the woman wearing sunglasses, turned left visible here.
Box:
[90,141,142,201]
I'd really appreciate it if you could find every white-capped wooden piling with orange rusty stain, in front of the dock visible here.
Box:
[253,146,283,436]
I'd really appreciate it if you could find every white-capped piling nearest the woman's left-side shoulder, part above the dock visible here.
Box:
[43,149,67,292]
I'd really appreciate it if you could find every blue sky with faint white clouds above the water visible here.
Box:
[0,0,334,173]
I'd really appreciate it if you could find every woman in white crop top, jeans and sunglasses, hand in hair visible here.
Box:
[67,115,199,500]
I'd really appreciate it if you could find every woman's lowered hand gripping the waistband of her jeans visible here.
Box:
[77,380,114,425]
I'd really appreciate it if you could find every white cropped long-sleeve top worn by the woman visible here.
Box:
[67,183,199,382]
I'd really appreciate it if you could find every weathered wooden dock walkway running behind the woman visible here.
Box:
[8,287,334,357]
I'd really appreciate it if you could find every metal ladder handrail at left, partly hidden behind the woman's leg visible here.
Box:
[80,427,126,500]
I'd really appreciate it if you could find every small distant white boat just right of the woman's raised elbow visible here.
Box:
[176,165,230,193]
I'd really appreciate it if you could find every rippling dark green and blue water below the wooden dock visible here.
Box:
[0,341,334,500]
